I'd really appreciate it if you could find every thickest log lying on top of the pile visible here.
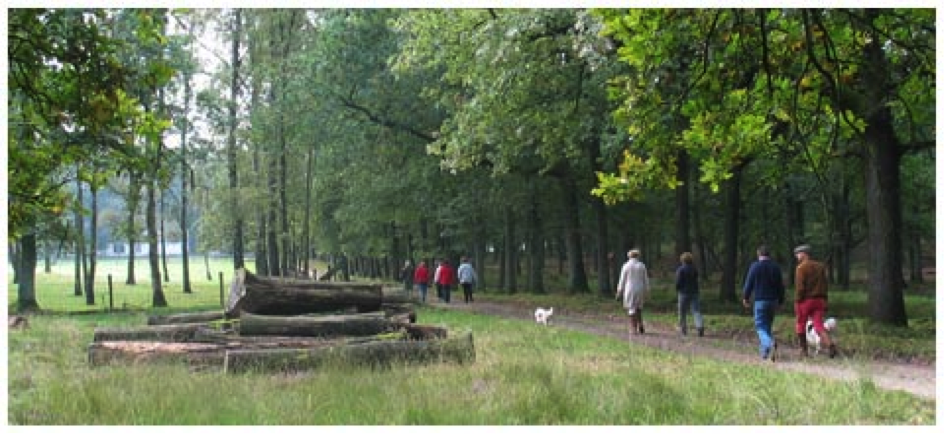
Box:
[226,269,383,317]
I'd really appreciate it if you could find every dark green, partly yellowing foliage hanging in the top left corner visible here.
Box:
[7,9,172,238]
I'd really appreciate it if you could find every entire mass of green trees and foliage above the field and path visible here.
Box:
[8,8,936,325]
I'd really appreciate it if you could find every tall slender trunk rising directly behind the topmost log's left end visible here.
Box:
[226,8,245,270]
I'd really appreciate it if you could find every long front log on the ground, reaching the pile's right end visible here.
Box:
[223,333,475,373]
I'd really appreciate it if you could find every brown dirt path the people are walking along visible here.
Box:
[434,301,936,400]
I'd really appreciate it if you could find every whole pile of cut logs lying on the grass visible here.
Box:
[88,269,475,372]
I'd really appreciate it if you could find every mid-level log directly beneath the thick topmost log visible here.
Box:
[239,312,394,337]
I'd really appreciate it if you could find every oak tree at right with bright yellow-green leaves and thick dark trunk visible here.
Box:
[600,9,935,325]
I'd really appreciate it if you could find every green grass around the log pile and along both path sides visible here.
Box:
[8,263,935,425]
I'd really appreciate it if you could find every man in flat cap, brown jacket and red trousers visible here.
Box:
[793,244,837,358]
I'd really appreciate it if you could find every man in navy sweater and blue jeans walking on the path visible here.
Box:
[741,245,785,362]
